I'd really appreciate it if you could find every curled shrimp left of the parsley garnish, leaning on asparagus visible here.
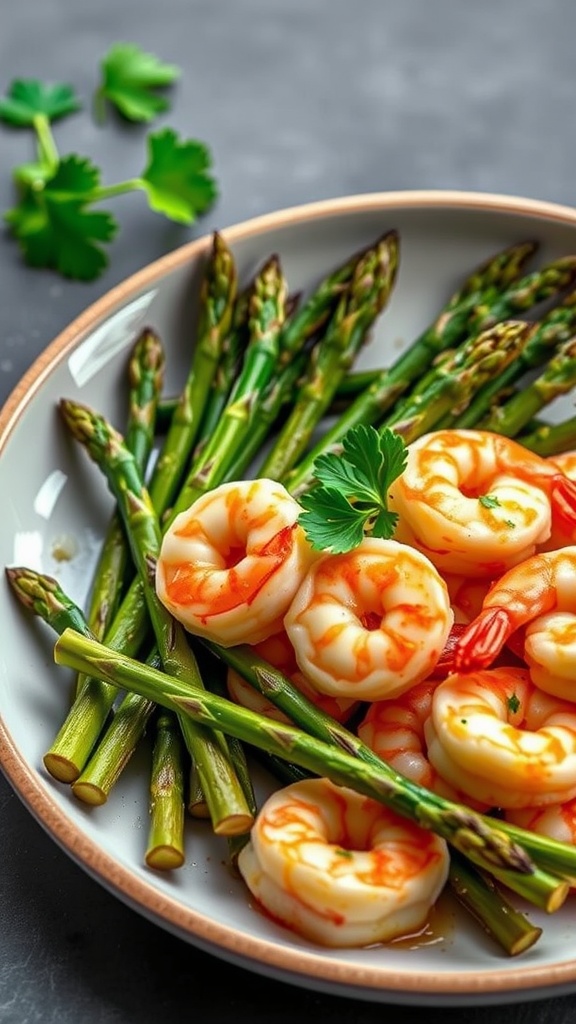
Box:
[156,479,317,647]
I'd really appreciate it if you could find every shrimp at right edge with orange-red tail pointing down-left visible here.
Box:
[454,546,576,679]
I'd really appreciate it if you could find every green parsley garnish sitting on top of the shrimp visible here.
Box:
[298,425,408,554]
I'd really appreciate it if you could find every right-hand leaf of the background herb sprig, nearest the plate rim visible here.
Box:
[140,128,218,224]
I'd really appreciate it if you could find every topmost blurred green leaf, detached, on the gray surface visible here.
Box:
[96,43,180,122]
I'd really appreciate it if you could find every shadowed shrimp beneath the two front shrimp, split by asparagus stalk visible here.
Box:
[227,630,358,722]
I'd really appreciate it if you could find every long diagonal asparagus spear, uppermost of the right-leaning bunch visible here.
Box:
[284,242,536,493]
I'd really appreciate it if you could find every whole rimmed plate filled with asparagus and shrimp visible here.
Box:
[0,191,576,1005]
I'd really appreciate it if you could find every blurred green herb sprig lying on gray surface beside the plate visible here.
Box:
[0,43,218,281]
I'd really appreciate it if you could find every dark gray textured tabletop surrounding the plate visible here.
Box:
[0,0,576,1024]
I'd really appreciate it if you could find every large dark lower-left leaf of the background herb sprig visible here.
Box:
[5,156,117,281]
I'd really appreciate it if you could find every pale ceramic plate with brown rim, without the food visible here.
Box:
[0,193,576,1004]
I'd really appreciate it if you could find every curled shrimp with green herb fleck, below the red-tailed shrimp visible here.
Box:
[424,668,576,808]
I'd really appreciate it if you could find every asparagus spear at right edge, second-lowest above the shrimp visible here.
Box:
[478,338,576,437]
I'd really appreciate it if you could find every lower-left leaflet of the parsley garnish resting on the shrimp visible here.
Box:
[298,487,366,554]
